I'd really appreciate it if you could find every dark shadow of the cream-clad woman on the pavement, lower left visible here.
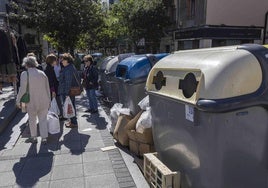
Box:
[13,144,54,187]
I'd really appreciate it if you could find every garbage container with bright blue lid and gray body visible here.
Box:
[116,54,168,115]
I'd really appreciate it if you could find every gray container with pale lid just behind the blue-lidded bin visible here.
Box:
[102,53,133,104]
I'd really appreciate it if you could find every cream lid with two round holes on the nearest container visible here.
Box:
[146,45,268,111]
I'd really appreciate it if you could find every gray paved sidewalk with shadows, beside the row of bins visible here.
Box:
[0,93,149,188]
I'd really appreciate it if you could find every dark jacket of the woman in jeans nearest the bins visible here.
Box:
[83,65,99,89]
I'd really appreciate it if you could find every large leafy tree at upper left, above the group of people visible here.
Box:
[8,0,103,53]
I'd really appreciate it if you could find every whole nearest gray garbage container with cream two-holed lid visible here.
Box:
[146,44,268,188]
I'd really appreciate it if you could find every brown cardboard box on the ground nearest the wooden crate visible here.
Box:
[128,128,155,156]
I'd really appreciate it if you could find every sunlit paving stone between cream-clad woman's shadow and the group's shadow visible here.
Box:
[54,153,82,166]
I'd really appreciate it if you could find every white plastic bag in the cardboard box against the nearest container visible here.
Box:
[136,107,152,133]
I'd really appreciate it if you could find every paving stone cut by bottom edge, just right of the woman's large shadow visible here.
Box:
[50,177,85,188]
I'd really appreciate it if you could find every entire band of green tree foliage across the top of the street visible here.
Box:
[10,0,169,53]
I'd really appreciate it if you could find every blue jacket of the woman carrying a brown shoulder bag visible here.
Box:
[59,64,80,96]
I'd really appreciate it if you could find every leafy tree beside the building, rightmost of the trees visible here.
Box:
[112,0,169,53]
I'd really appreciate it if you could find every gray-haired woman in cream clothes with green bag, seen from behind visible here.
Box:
[16,56,50,143]
